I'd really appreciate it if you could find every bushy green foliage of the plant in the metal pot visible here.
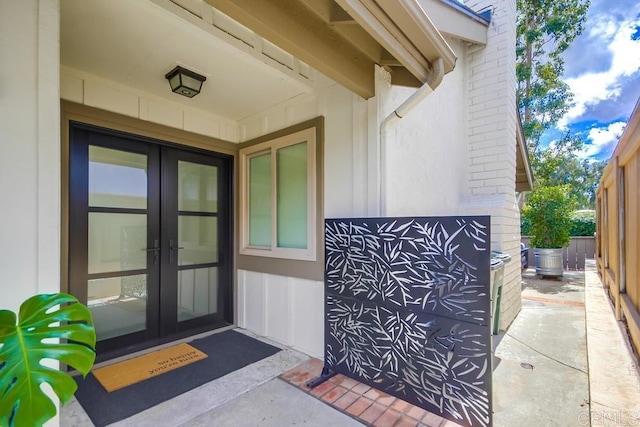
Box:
[522,185,575,249]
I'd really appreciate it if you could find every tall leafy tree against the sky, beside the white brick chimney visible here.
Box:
[516,0,590,152]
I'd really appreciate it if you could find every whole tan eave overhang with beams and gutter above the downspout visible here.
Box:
[205,0,456,98]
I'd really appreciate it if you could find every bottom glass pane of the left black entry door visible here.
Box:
[87,274,147,341]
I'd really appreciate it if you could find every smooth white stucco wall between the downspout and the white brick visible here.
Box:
[378,40,468,216]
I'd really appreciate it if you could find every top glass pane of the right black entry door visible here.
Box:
[178,161,218,213]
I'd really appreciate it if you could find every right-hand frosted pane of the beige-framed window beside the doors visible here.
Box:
[276,142,307,249]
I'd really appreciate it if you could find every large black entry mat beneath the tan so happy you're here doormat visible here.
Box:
[76,331,280,427]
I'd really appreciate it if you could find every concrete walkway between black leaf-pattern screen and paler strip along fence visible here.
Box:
[493,269,589,427]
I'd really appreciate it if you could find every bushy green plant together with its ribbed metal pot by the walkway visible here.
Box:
[522,185,574,277]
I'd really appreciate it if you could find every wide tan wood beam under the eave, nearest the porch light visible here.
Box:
[205,0,375,98]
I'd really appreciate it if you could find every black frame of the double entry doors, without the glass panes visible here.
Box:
[68,121,233,354]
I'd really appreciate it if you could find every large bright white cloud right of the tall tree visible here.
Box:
[558,16,640,129]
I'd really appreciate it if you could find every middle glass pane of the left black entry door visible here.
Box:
[88,212,147,274]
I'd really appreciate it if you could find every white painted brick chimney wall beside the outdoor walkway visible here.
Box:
[465,0,521,329]
